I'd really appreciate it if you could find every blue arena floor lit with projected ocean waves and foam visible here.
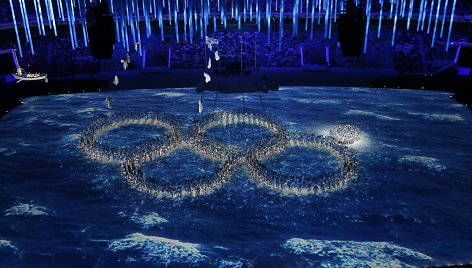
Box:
[0,87,472,267]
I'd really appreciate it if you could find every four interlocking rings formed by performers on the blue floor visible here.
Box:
[80,109,357,198]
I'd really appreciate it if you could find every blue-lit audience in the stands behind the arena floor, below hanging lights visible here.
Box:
[0,24,471,75]
